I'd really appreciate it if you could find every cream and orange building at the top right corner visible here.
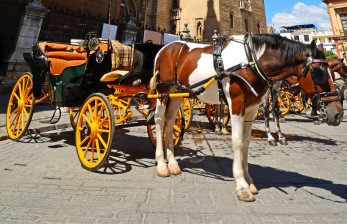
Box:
[323,0,347,60]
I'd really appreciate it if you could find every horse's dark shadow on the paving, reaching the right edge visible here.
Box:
[178,156,347,203]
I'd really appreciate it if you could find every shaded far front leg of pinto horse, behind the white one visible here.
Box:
[242,105,259,194]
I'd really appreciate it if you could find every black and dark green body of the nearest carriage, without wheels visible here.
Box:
[23,43,112,107]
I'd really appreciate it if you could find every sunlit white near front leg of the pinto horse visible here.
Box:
[231,114,255,201]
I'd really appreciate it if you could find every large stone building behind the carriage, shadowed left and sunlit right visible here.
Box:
[0,0,267,82]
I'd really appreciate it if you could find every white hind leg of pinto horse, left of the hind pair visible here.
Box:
[154,99,170,177]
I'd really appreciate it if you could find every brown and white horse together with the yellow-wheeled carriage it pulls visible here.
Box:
[7,30,343,201]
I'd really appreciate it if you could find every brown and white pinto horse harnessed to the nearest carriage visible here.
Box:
[150,35,343,201]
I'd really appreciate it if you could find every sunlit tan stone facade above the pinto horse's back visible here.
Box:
[146,0,267,41]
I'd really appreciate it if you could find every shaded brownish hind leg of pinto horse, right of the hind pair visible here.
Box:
[164,98,184,175]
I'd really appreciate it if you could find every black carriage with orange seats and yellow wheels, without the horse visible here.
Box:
[6,33,184,170]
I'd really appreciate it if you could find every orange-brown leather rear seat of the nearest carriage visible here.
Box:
[38,42,87,75]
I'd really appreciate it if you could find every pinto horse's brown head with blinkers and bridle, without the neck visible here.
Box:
[298,46,343,126]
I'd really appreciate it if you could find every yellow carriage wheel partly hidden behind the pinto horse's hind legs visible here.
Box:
[147,107,185,148]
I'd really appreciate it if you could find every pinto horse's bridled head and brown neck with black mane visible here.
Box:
[252,35,343,126]
